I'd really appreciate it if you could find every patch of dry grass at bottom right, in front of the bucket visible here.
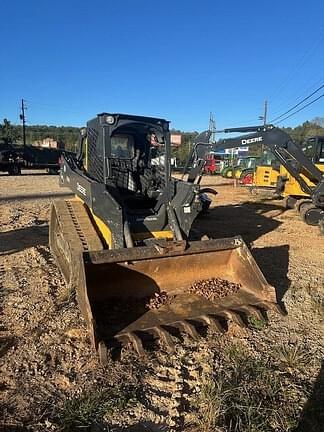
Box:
[192,344,301,432]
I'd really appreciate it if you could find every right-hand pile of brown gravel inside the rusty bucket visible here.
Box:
[188,278,242,300]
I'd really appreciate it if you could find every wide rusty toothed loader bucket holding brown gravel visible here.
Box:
[74,237,280,363]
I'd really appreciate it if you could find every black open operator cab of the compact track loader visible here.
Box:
[81,113,170,213]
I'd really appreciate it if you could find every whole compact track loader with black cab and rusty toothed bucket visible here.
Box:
[49,113,281,364]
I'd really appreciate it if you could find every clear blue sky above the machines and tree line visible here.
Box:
[0,0,324,130]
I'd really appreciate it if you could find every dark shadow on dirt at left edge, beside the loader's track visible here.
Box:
[0,225,48,255]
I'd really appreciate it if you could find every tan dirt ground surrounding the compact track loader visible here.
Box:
[0,173,324,432]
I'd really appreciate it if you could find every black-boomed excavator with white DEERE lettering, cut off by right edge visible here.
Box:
[213,125,324,234]
